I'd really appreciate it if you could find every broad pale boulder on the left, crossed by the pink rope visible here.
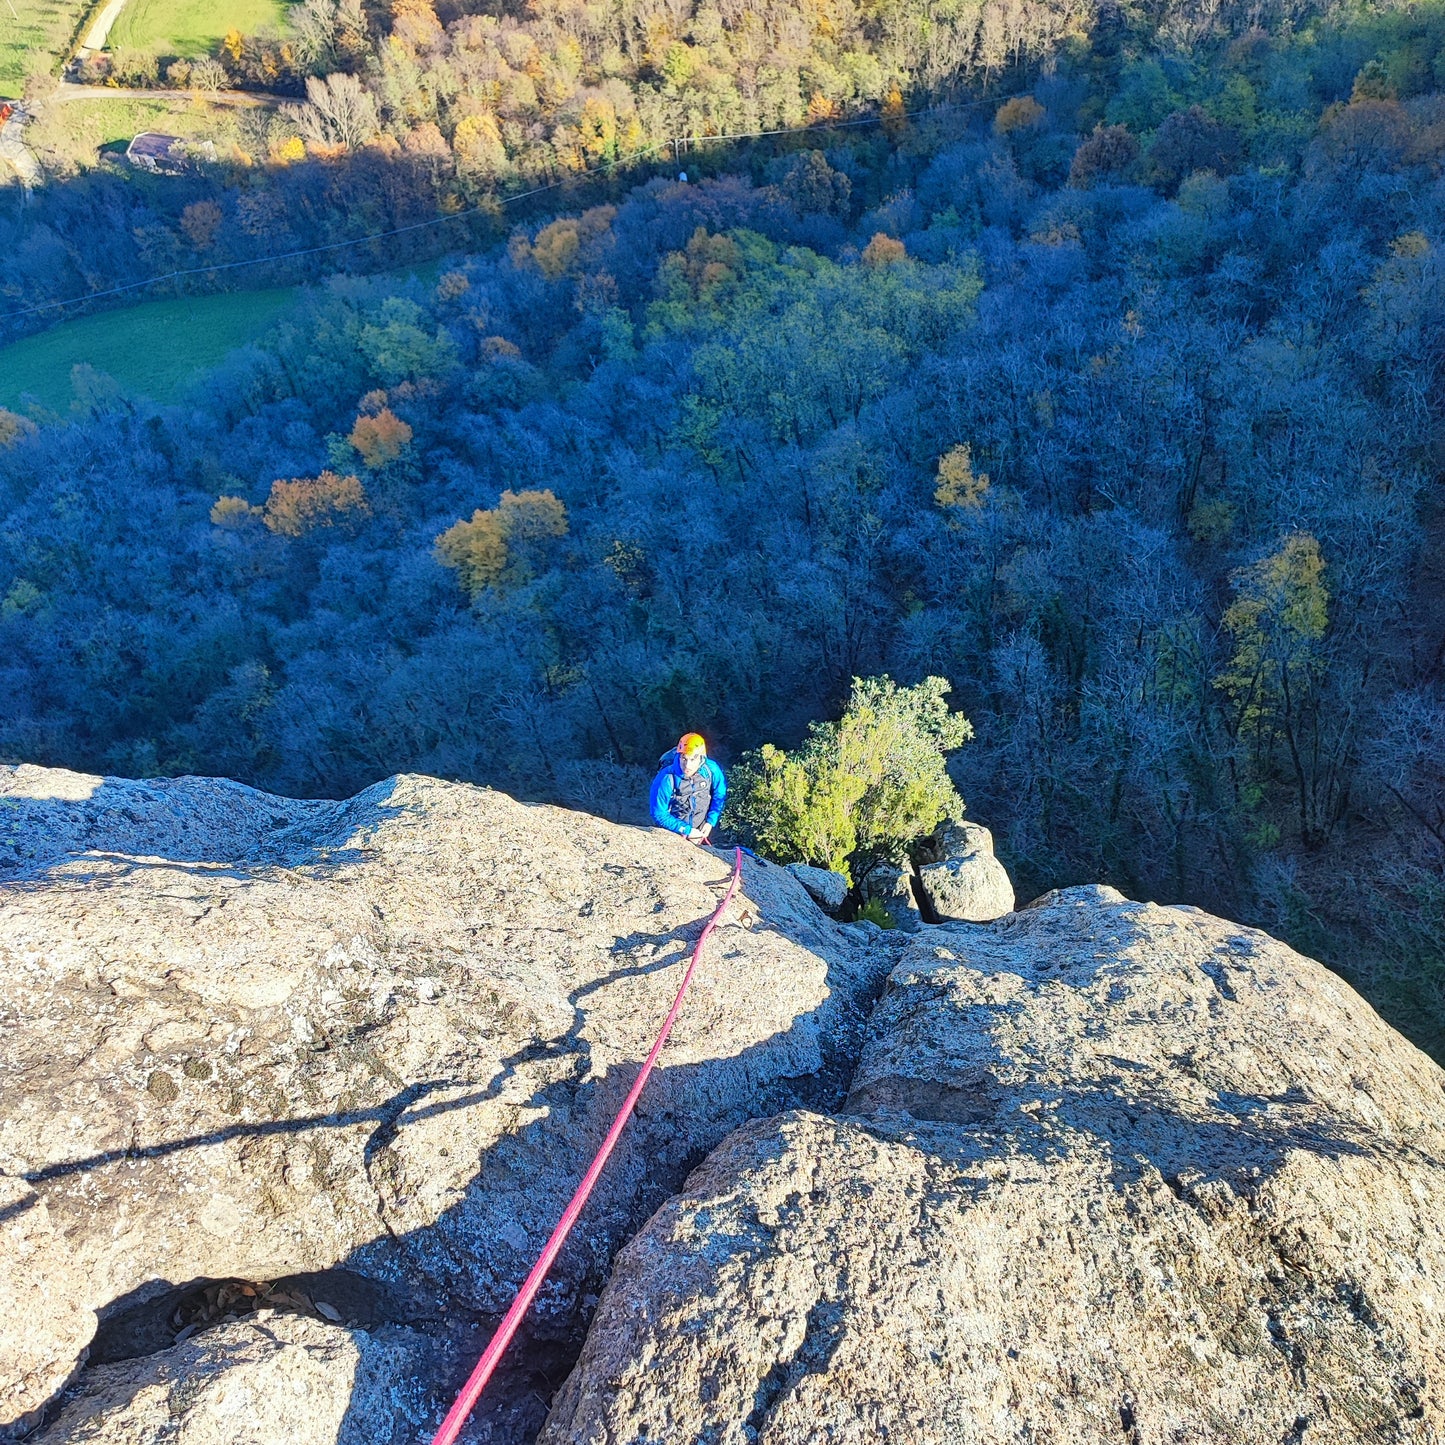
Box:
[0,767,887,1439]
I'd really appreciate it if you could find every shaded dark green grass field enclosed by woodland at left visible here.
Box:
[0,289,296,412]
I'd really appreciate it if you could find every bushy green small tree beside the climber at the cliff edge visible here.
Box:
[727,678,974,880]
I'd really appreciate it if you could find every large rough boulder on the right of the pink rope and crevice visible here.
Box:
[540,889,1445,1445]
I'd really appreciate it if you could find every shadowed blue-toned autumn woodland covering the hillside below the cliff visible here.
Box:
[0,0,1445,1053]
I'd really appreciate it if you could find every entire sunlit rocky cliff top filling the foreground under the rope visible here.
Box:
[0,767,1445,1445]
